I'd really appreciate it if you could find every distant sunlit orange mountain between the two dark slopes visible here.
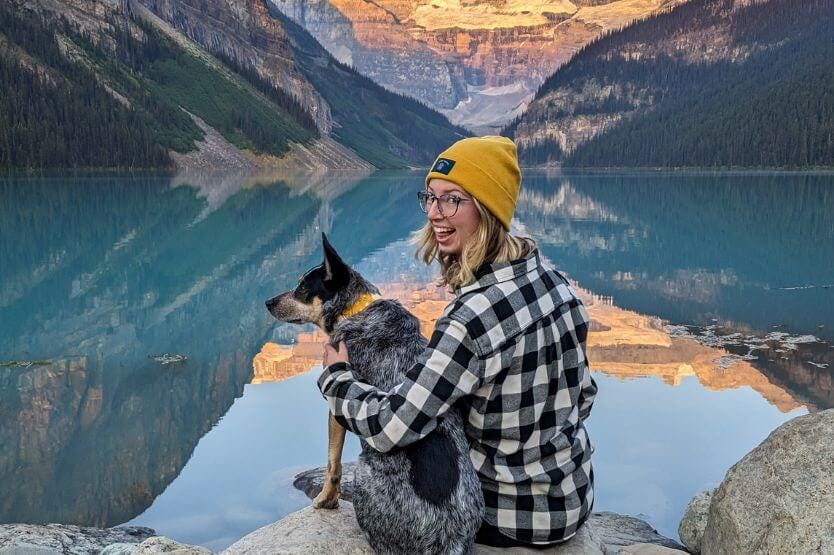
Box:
[269,0,680,132]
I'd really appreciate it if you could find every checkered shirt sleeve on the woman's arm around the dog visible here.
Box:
[318,317,483,453]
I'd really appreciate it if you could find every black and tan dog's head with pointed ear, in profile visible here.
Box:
[266,233,379,333]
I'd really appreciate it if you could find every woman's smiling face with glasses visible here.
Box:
[426,179,481,256]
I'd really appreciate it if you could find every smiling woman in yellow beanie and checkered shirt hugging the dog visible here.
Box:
[319,137,596,547]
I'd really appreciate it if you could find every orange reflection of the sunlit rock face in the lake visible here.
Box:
[252,270,813,412]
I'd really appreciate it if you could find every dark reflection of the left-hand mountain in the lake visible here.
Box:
[0,175,426,526]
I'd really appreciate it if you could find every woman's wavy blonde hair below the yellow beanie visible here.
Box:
[412,198,536,290]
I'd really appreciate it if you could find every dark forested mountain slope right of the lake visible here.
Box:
[505,0,834,167]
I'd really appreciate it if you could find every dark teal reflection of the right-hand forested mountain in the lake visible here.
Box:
[517,173,834,409]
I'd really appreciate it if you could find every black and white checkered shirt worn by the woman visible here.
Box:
[319,251,597,543]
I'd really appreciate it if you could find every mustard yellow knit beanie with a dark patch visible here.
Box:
[426,135,521,231]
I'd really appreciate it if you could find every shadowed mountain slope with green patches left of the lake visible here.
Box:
[0,0,466,169]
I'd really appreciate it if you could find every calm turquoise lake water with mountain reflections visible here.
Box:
[0,172,834,550]
